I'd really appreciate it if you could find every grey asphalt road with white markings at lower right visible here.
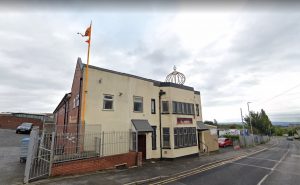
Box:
[168,138,300,185]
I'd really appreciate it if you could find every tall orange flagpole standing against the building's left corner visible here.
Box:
[81,21,92,127]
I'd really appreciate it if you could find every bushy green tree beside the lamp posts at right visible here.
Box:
[244,109,273,135]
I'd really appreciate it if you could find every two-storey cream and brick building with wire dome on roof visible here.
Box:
[54,58,217,159]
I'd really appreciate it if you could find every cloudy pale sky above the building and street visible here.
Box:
[0,1,300,122]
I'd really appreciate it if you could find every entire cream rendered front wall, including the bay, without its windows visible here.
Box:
[81,68,202,159]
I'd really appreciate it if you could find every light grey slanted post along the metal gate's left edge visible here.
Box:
[24,129,38,183]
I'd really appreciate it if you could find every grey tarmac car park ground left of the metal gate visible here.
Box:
[0,129,29,185]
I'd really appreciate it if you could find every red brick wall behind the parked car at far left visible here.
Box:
[0,115,43,130]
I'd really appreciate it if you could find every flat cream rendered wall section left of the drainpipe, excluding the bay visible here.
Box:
[84,68,160,159]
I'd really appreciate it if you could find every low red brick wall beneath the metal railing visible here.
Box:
[51,152,142,176]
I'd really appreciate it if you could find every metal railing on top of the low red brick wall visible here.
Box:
[53,125,132,163]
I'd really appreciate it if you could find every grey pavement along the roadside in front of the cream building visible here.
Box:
[32,138,272,185]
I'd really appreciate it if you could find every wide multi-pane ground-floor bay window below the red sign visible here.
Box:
[174,127,197,148]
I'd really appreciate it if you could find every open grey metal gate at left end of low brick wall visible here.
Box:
[24,129,55,183]
